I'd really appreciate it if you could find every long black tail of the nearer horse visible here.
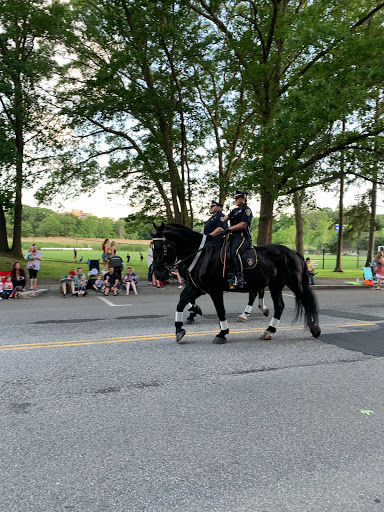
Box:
[287,251,321,338]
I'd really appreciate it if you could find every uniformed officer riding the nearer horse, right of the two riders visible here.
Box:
[224,190,252,288]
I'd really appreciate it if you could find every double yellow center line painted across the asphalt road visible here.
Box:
[0,323,376,352]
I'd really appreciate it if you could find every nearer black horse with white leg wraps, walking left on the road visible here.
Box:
[153,223,321,344]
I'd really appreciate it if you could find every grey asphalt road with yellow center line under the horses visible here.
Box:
[0,286,384,512]
